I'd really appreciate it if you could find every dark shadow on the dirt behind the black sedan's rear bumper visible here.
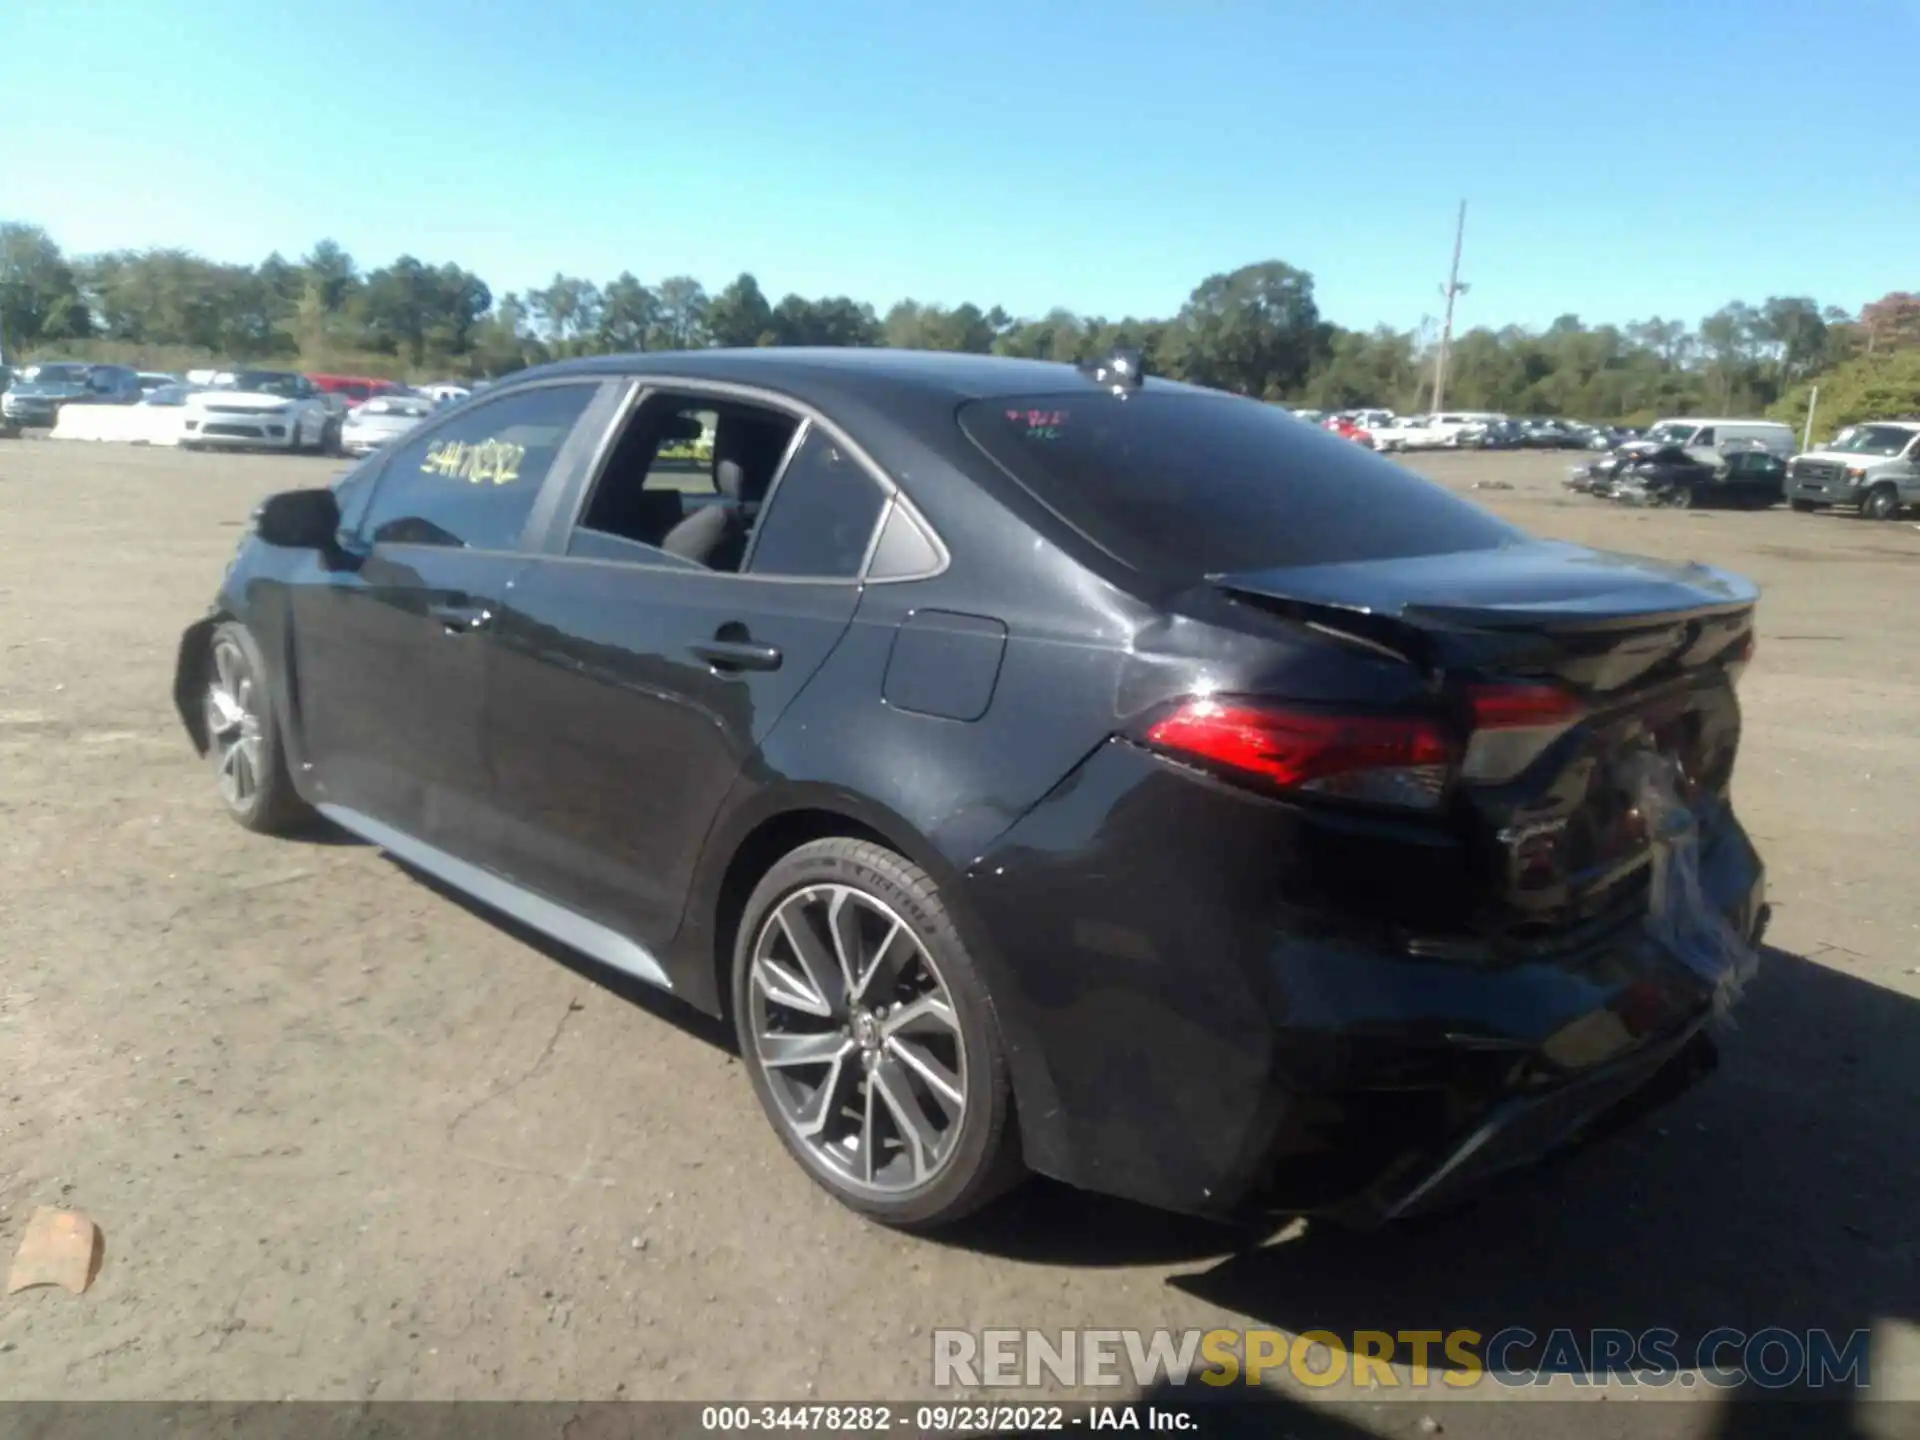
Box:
[950,948,1920,1413]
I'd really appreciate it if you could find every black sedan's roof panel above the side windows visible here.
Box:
[513,346,1221,399]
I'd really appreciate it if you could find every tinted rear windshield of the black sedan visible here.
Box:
[960,390,1526,580]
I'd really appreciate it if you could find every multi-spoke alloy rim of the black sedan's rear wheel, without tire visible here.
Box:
[747,885,968,1194]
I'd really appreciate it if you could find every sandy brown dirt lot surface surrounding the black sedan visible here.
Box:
[0,442,1920,1434]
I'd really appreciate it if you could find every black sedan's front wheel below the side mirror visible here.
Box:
[202,620,313,835]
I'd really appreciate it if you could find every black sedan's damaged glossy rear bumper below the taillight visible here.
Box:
[968,747,1766,1221]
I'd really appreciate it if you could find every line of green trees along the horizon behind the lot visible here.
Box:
[0,223,1920,428]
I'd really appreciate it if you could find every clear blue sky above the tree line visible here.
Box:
[0,0,1920,326]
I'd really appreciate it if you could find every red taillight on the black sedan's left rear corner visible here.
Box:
[1144,699,1457,810]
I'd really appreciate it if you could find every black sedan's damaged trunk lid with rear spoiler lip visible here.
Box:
[1210,541,1759,945]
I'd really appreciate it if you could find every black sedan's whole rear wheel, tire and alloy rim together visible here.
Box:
[732,837,1021,1229]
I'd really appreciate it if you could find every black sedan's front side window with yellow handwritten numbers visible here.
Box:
[363,384,595,549]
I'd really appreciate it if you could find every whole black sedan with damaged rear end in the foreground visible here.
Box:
[175,349,1764,1225]
